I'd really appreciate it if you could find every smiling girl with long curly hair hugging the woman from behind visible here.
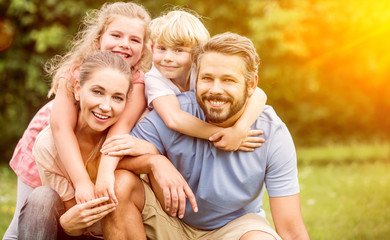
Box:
[4,2,151,239]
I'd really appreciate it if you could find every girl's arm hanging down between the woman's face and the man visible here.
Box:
[95,84,146,203]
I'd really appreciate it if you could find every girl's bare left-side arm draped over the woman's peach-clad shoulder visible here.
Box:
[50,78,95,203]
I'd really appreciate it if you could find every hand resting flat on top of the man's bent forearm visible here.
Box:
[100,134,158,157]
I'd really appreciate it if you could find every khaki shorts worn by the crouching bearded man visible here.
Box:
[142,182,281,240]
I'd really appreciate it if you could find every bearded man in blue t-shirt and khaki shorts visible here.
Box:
[103,33,309,240]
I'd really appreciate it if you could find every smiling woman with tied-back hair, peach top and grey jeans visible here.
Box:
[19,51,157,239]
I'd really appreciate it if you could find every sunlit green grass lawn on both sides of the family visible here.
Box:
[0,143,390,240]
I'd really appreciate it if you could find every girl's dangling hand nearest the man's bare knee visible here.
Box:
[95,171,118,205]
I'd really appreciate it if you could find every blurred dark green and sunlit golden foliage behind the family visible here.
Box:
[0,0,390,161]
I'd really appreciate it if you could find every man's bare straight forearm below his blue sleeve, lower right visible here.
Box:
[269,194,310,240]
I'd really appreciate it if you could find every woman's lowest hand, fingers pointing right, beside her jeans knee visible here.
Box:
[60,197,115,236]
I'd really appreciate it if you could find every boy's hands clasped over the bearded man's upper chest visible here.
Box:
[210,126,265,152]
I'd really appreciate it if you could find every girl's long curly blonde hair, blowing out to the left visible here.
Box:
[45,2,151,97]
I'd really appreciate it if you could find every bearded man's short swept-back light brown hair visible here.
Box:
[193,32,260,85]
